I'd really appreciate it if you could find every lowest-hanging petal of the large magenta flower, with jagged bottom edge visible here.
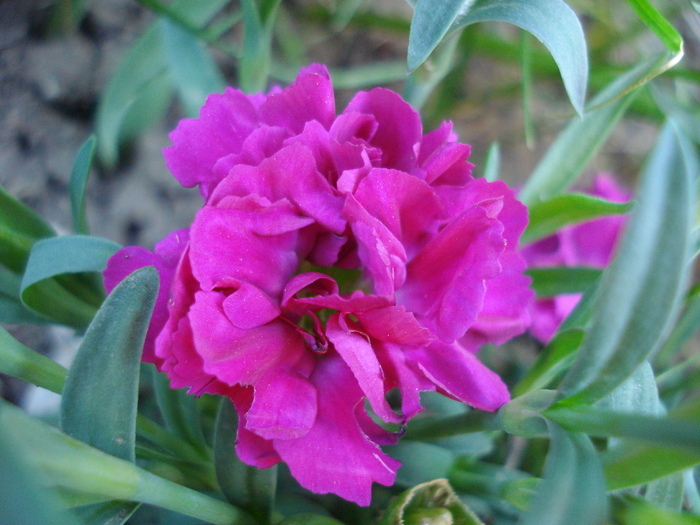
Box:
[274,354,400,506]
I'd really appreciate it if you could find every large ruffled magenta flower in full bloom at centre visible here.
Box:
[105,65,532,505]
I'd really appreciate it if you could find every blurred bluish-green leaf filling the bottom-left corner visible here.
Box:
[0,418,78,525]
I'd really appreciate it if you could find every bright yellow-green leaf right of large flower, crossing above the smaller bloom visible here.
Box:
[520,193,632,244]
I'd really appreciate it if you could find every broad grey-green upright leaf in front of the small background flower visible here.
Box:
[560,121,697,403]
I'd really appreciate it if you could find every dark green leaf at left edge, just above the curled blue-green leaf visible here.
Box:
[0,186,56,273]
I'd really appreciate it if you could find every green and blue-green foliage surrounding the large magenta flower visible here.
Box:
[0,0,700,525]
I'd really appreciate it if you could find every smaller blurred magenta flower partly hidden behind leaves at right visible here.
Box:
[521,173,632,344]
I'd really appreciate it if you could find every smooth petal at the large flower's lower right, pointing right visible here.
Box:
[407,341,510,411]
